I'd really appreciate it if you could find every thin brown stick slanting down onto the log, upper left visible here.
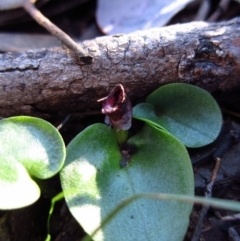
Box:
[23,0,93,64]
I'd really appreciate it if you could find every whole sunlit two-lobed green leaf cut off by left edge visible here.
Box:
[0,116,66,209]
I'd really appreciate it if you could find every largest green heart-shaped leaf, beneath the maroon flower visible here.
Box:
[60,124,194,241]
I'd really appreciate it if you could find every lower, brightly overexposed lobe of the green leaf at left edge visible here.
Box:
[0,157,40,209]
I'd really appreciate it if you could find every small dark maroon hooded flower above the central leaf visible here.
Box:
[98,84,132,130]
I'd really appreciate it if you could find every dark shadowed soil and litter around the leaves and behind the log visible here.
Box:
[0,0,240,241]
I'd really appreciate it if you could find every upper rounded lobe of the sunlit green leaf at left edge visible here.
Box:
[0,116,65,179]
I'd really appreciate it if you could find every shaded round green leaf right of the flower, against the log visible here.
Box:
[133,83,222,147]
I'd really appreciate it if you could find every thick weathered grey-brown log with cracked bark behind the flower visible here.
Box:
[0,18,240,116]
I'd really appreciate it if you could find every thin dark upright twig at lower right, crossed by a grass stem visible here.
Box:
[191,157,221,241]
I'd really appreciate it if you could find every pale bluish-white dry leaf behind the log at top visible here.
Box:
[97,0,192,34]
